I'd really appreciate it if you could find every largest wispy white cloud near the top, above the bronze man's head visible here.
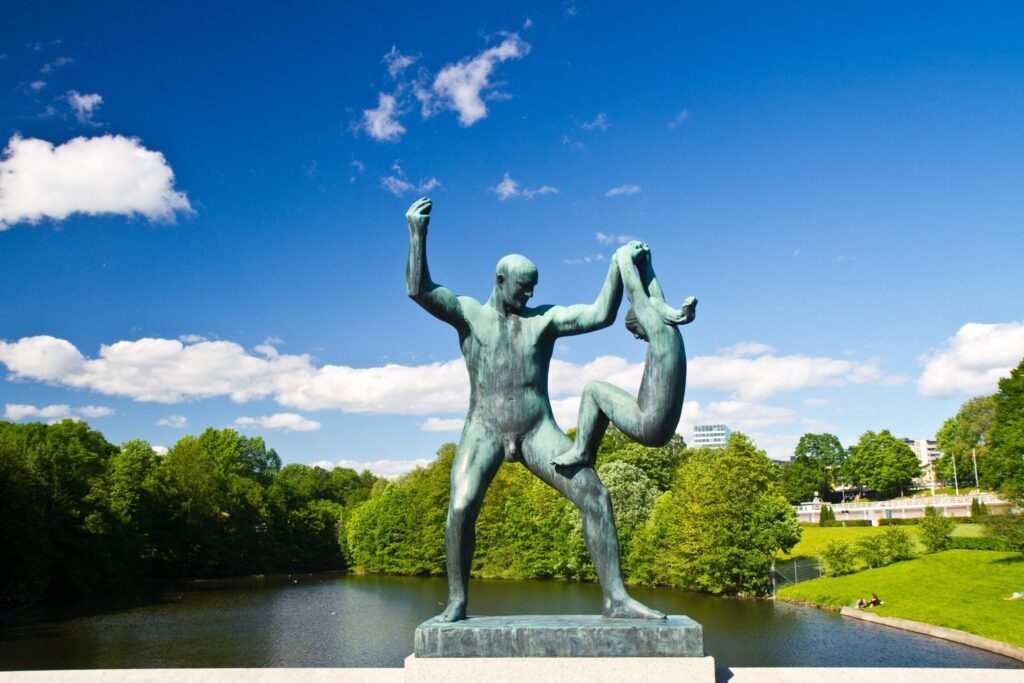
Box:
[428,33,529,126]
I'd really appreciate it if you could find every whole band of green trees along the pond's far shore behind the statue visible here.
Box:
[0,420,800,606]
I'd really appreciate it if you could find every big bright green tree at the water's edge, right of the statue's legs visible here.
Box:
[631,432,800,593]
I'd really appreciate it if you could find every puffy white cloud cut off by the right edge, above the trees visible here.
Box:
[918,322,1024,398]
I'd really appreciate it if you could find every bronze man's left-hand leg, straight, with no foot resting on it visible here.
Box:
[434,423,502,622]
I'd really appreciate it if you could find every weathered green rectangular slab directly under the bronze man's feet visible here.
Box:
[414,614,705,659]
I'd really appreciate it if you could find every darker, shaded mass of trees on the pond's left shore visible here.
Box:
[0,420,377,605]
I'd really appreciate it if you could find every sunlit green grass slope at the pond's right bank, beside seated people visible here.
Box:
[778,552,1024,647]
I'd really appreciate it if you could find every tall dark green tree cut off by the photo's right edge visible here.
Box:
[985,360,1024,499]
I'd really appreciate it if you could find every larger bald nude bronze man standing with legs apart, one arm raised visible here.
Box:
[406,198,665,622]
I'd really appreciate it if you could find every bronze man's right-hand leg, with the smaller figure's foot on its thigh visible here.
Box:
[523,420,665,618]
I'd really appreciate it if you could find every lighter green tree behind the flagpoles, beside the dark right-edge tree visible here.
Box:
[935,396,995,485]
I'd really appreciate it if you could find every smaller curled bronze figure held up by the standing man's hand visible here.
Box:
[552,241,697,467]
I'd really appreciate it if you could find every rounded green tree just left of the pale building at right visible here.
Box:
[843,429,921,498]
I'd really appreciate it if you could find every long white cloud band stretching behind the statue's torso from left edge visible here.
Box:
[0,336,903,416]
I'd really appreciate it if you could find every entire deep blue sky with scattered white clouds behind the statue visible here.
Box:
[0,1,1024,472]
